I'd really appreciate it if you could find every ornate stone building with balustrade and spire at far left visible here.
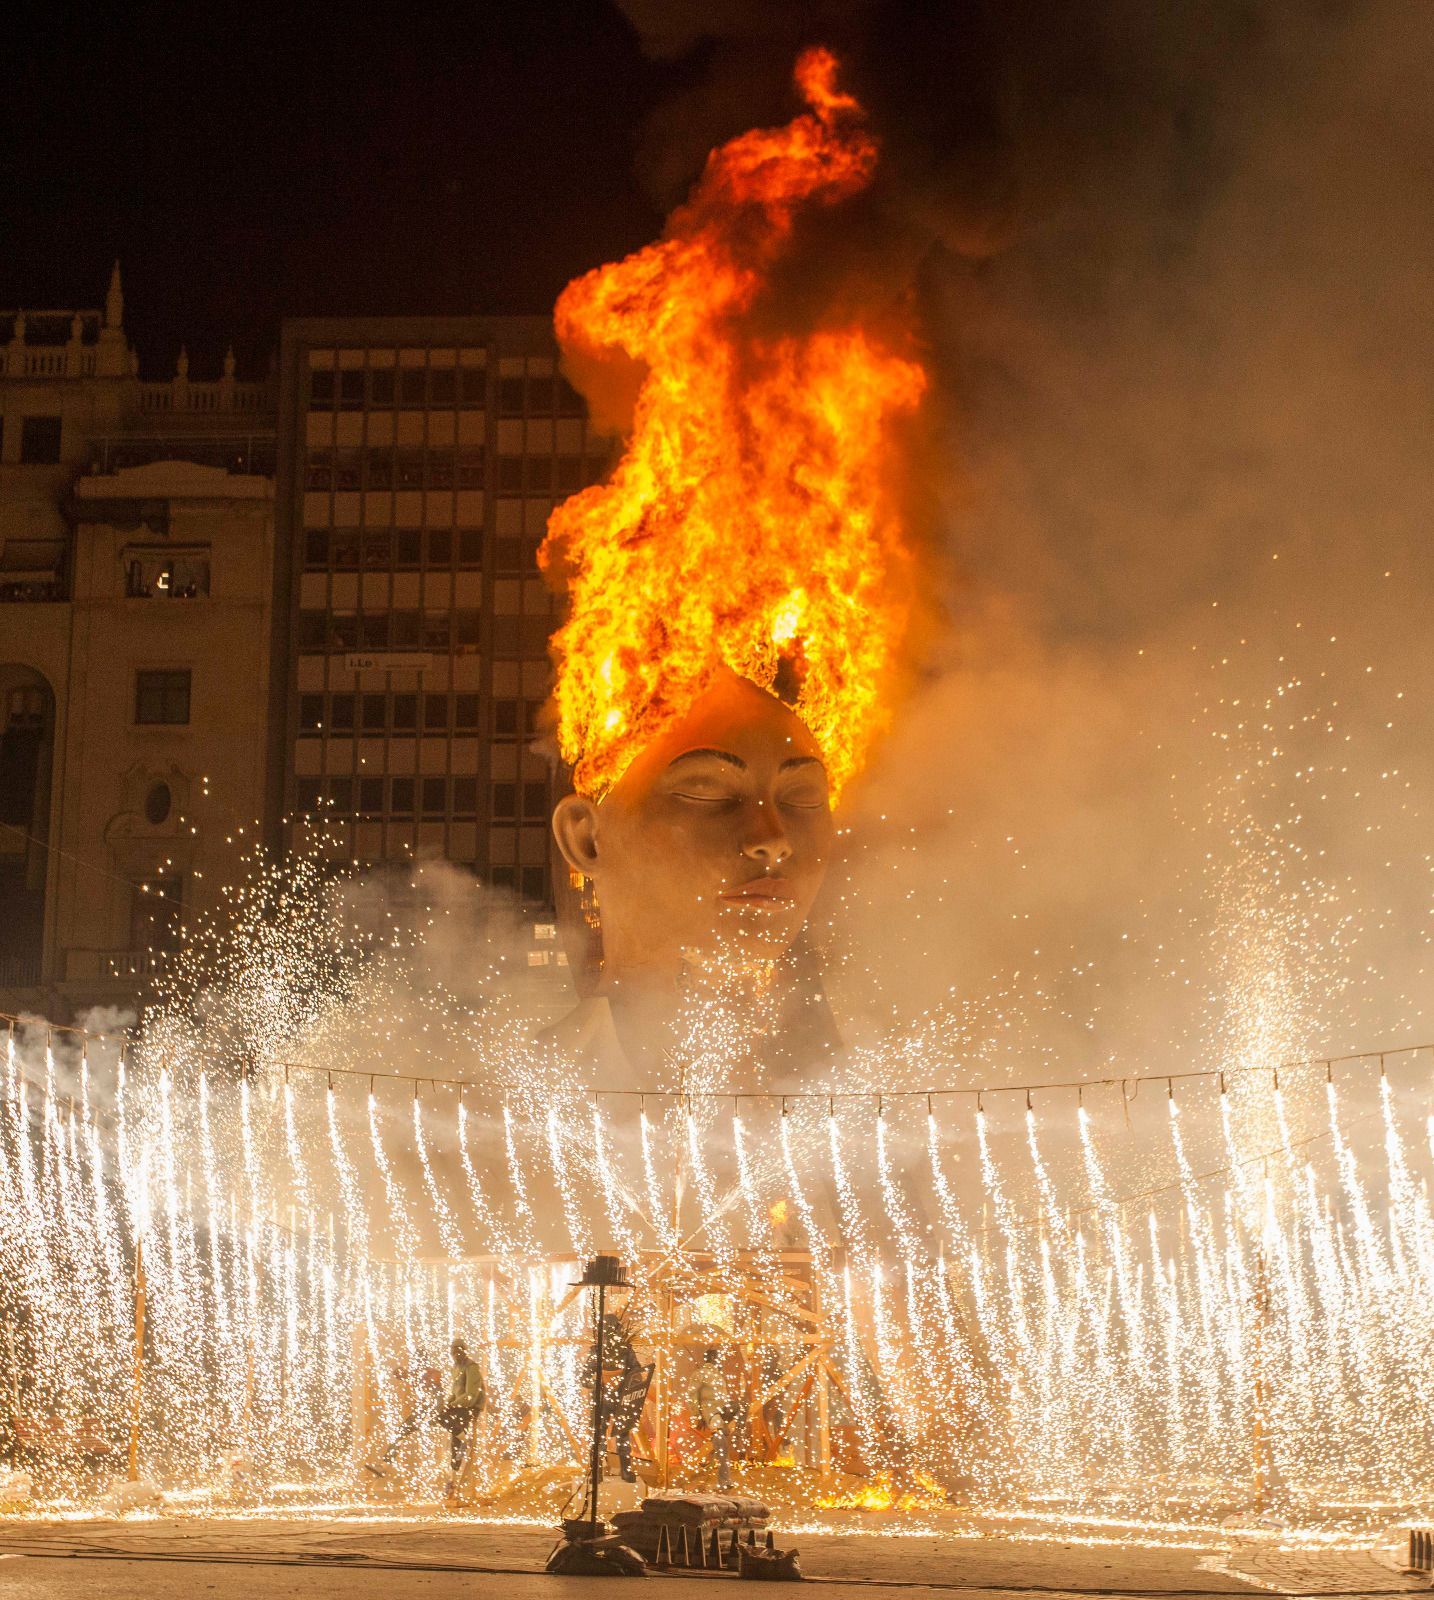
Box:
[0,269,275,1014]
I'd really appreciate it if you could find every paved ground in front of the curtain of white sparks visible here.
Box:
[0,1517,1429,1600]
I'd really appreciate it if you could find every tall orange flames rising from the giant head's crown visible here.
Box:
[539,50,927,795]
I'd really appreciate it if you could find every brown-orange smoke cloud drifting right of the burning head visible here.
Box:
[604,0,1434,1075]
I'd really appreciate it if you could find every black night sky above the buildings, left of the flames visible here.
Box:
[0,3,674,370]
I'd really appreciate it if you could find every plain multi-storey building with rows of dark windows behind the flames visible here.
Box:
[275,317,610,928]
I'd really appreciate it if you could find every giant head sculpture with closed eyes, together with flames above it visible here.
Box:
[539,50,925,1082]
